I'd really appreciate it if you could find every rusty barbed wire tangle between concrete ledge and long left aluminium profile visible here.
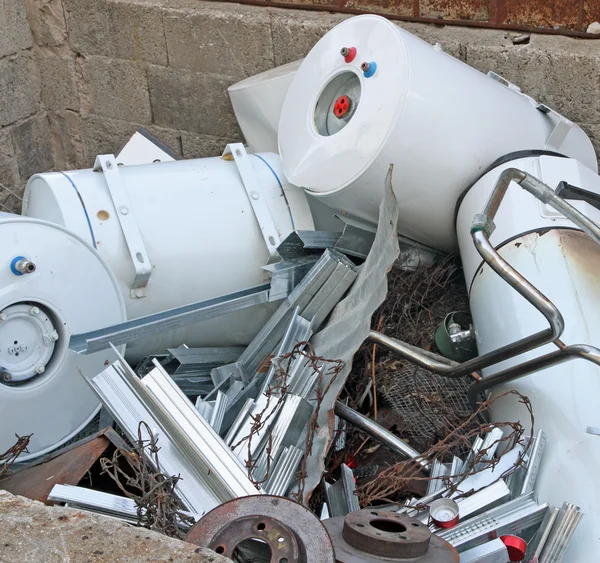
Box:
[100,421,195,539]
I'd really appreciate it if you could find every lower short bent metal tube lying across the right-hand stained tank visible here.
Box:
[468,344,600,408]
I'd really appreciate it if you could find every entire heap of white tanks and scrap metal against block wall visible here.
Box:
[0,15,600,563]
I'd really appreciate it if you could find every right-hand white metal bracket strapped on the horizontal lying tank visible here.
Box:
[223,143,281,262]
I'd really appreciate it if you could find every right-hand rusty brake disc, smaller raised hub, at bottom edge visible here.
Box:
[323,508,459,563]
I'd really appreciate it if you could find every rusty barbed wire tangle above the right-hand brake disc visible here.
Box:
[358,390,535,509]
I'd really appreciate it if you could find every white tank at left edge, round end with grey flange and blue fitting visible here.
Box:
[0,213,126,461]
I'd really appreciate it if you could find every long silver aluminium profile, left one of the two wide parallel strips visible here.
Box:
[86,357,219,514]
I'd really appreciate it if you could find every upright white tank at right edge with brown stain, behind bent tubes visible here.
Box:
[457,156,600,563]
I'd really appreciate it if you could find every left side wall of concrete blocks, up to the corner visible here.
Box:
[0,0,54,212]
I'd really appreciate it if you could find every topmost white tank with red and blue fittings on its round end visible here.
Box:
[279,15,597,250]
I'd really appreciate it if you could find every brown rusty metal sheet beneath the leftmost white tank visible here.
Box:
[0,428,129,505]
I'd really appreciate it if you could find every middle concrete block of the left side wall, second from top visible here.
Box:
[0,52,40,127]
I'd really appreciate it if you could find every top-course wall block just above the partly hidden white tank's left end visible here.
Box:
[164,2,275,78]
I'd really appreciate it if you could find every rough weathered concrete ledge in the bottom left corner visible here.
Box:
[0,491,231,563]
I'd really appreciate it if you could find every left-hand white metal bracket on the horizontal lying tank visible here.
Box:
[94,154,152,298]
